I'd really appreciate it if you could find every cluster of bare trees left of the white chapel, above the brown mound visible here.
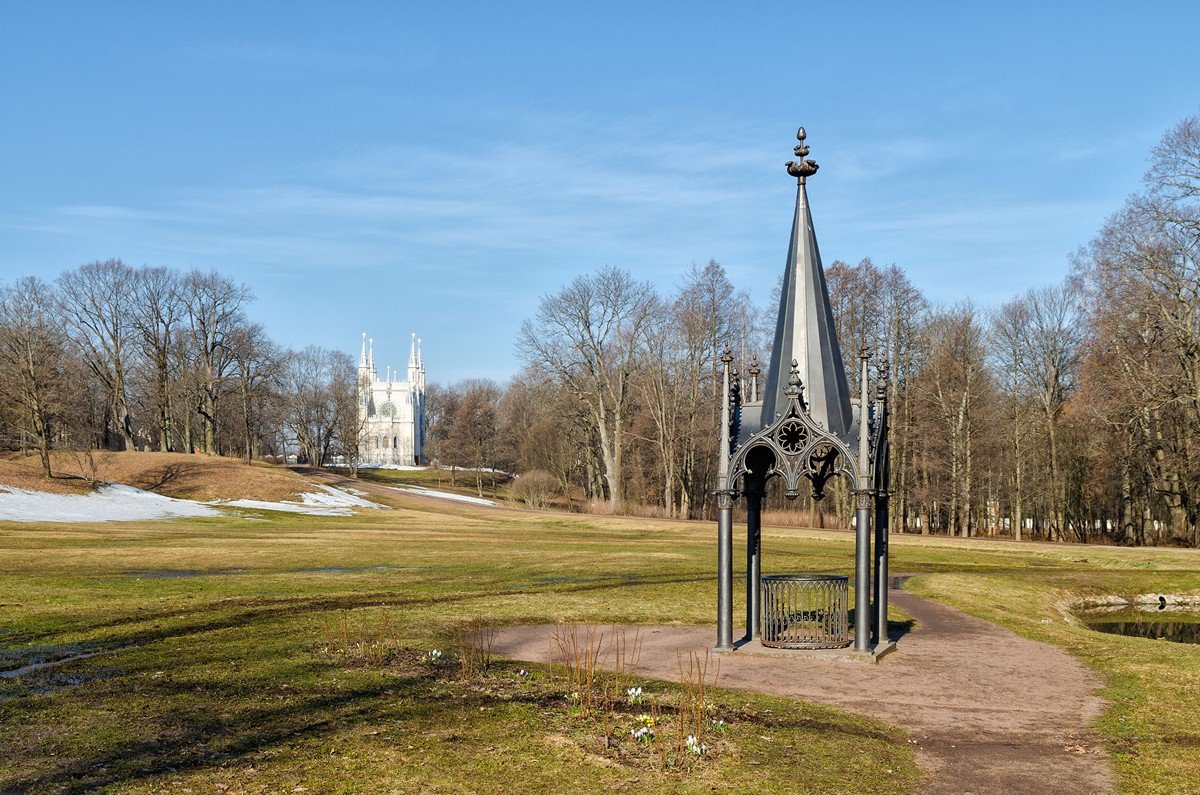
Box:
[0,259,358,476]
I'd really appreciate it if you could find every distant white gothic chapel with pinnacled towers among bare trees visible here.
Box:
[359,334,425,466]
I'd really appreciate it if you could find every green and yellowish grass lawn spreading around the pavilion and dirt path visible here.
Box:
[0,495,1200,793]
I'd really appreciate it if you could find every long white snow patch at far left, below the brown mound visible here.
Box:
[0,484,221,522]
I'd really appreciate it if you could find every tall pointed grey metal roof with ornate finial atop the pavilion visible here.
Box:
[762,127,857,442]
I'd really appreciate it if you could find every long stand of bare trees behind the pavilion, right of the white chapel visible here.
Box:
[430,110,1200,546]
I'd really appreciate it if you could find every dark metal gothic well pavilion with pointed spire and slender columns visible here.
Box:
[716,127,892,656]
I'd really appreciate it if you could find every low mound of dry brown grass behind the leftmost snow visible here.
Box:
[0,452,313,502]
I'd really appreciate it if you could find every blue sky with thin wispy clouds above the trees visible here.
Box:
[0,2,1200,381]
